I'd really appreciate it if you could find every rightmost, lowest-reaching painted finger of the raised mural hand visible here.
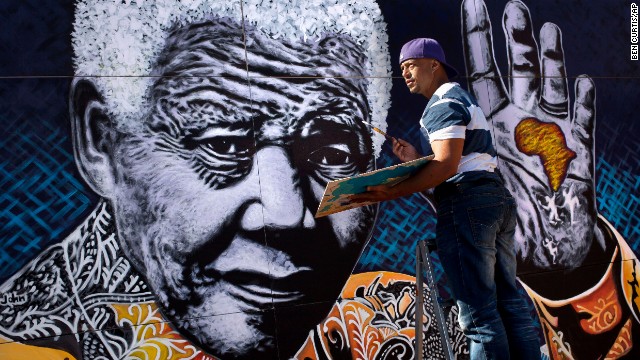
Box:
[571,75,596,178]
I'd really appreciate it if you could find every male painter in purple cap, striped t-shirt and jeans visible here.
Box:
[352,38,540,359]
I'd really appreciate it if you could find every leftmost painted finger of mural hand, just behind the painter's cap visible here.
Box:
[461,0,508,116]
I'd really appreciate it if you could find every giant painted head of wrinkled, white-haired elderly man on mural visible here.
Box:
[71,1,390,357]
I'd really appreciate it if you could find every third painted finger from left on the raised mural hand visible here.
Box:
[540,23,569,118]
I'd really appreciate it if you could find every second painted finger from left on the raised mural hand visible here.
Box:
[502,1,540,111]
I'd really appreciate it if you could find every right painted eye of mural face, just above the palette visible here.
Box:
[307,144,357,181]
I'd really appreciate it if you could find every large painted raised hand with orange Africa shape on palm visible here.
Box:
[462,0,604,269]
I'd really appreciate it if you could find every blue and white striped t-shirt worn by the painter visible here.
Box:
[420,82,497,183]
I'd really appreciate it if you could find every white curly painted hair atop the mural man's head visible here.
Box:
[72,0,391,157]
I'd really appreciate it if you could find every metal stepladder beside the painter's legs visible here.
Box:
[414,238,455,360]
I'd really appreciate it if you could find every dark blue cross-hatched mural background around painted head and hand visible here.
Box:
[0,0,640,358]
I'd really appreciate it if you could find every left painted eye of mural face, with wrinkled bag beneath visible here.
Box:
[185,135,255,189]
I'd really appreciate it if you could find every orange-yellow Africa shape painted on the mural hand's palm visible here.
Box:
[515,118,576,191]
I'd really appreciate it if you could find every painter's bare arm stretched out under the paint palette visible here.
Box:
[349,139,464,202]
